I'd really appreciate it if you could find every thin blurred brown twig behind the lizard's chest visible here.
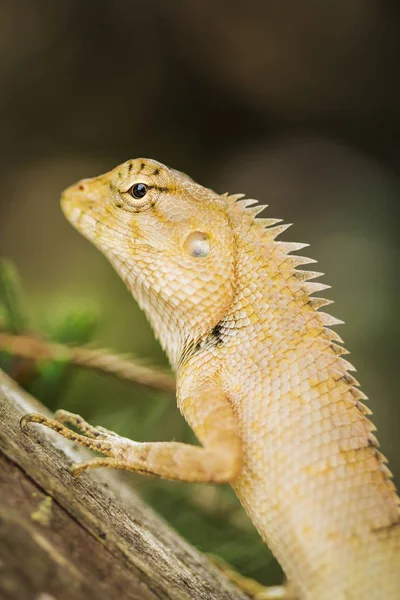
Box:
[0,332,175,394]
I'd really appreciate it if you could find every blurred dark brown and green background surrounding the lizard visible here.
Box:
[0,0,400,583]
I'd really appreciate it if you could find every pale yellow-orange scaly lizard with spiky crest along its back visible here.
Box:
[22,158,400,600]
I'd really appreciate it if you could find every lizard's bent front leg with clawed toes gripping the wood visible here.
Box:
[21,383,241,483]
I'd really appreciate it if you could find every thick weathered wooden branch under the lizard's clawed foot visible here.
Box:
[0,371,247,600]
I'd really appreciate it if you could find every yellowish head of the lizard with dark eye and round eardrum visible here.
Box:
[61,159,234,364]
